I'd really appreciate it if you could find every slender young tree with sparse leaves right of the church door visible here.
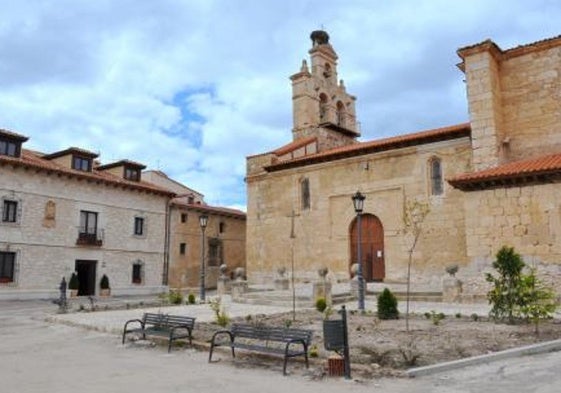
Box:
[403,199,430,331]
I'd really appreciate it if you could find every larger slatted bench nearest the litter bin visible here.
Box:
[208,323,313,375]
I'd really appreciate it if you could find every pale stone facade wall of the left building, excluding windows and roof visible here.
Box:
[0,166,167,298]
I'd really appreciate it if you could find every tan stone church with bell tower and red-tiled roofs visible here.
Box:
[246,31,561,294]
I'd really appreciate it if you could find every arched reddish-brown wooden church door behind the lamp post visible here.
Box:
[349,214,386,282]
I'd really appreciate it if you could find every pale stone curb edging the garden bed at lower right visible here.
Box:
[406,339,561,377]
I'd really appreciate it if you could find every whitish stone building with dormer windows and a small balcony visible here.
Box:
[0,129,175,299]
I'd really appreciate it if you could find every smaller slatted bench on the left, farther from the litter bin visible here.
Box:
[123,313,195,352]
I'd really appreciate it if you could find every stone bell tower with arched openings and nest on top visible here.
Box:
[290,30,360,150]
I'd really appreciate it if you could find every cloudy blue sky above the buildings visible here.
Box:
[0,0,561,210]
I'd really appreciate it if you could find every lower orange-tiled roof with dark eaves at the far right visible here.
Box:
[447,153,561,191]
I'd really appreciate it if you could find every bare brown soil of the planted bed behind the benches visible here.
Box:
[195,310,561,378]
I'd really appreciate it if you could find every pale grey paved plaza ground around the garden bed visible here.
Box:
[0,290,561,393]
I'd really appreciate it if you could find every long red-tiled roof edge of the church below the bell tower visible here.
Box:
[265,123,471,172]
